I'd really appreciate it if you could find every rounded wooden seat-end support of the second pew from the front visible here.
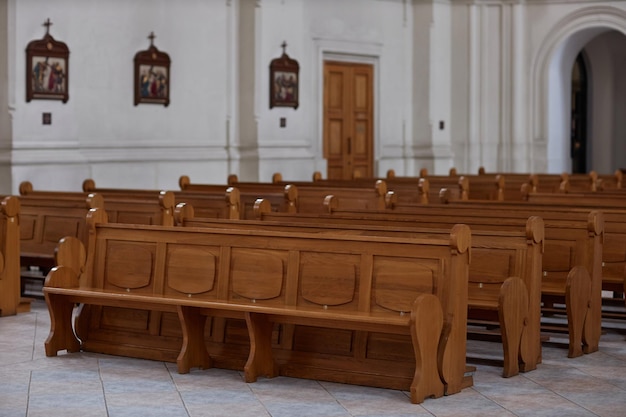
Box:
[498,277,538,378]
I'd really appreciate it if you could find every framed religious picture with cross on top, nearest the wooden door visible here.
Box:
[270,42,300,109]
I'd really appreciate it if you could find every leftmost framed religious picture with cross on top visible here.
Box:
[26,19,70,103]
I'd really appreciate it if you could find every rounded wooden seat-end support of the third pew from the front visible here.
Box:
[565,266,591,358]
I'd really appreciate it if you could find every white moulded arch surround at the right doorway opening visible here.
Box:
[528,6,626,172]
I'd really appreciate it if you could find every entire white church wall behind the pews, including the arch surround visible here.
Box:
[0,0,626,190]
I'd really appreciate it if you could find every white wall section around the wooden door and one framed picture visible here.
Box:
[256,0,411,181]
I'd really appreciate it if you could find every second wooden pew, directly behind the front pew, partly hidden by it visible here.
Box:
[175,200,544,377]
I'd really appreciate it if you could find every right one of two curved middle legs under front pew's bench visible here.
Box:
[244,312,278,382]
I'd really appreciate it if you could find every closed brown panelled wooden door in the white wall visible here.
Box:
[324,62,374,179]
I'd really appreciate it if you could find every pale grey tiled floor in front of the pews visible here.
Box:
[0,301,626,417]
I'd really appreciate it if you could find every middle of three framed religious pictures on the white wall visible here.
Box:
[135,33,171,107]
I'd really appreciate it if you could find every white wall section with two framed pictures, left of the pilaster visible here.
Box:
[10,0,232,189]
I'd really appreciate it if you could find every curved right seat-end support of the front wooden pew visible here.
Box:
[410,294,444,404]
